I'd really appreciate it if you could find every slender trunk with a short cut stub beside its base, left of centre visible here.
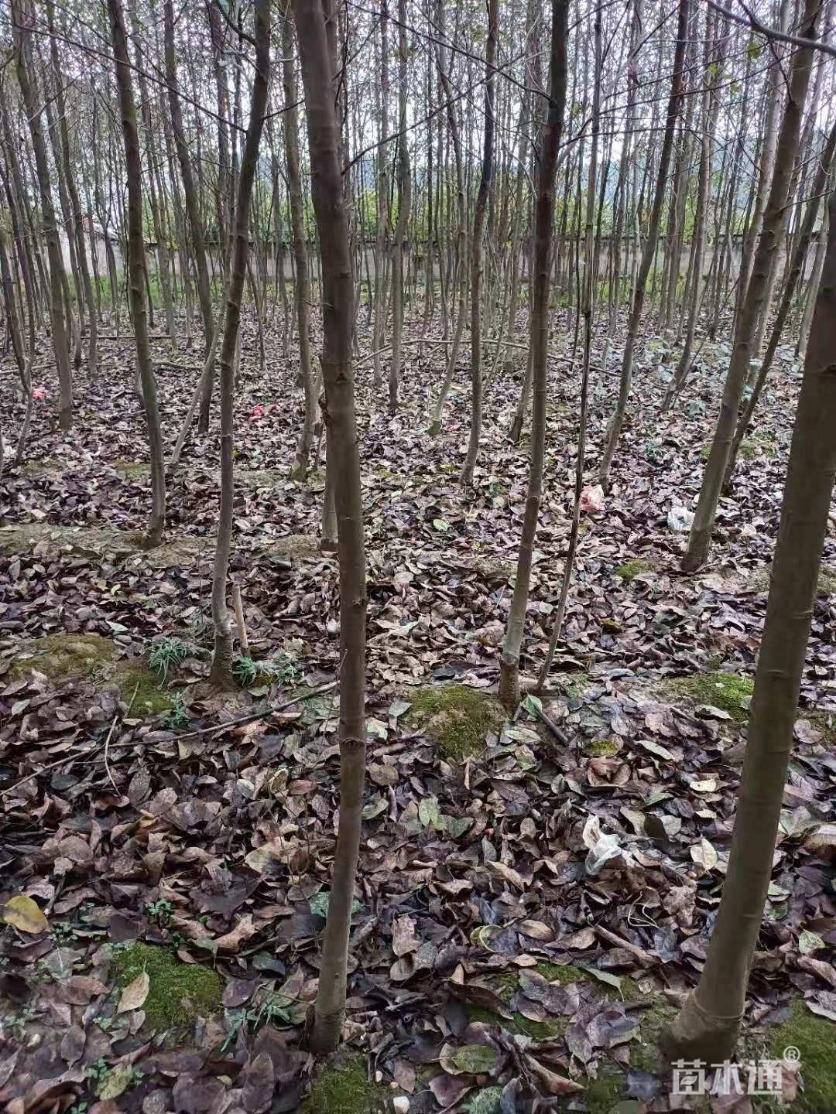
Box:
[210,0,270,686]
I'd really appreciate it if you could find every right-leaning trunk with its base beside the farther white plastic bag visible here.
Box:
[682,0,820,573]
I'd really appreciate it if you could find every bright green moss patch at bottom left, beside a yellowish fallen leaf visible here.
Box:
[110,941,223,1038]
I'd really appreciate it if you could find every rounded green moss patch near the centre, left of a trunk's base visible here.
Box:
[407,685,505,762]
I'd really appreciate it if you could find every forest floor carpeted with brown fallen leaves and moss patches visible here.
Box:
[0,309,836,1114]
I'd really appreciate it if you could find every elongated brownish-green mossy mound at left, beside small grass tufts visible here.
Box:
[9,633,173,715]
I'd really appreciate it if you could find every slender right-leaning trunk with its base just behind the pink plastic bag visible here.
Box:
[600,0,689,488]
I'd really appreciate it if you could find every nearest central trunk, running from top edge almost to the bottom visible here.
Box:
[297,0,366,1053]
